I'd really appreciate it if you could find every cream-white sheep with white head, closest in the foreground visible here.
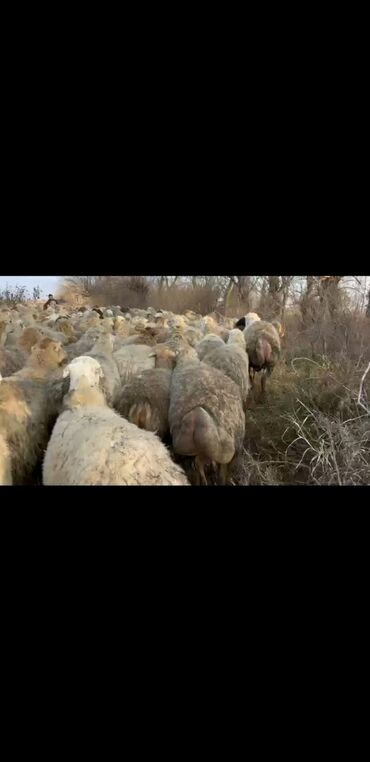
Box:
[43,357,189,486]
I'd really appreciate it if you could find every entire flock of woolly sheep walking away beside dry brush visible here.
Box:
[0,299,282,485]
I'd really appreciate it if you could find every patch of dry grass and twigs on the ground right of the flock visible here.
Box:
[231,358,370,485]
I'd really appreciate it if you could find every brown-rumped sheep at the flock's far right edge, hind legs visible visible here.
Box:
[243,320,281,398]
